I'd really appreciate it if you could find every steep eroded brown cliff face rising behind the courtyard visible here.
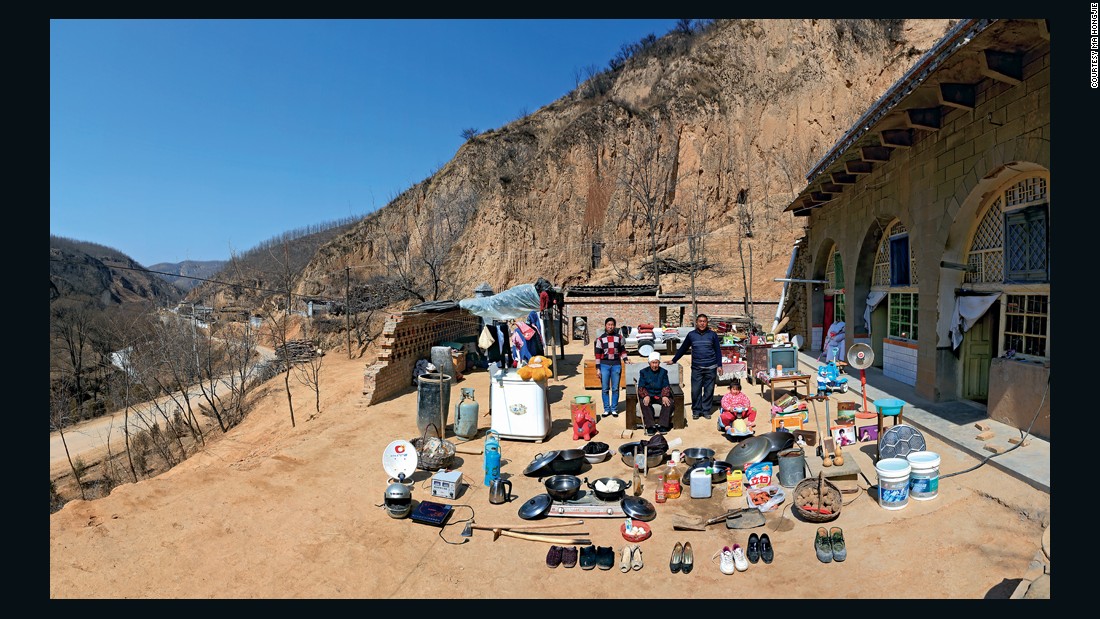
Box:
[299,20,952,299]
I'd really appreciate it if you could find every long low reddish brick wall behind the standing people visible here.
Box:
[565,296,779,334]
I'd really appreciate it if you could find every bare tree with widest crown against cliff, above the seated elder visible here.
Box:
[619,112,680,288]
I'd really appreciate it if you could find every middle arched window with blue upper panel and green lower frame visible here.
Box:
[871,220,919,341]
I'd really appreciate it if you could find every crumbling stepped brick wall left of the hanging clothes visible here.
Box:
[363,309,481,406]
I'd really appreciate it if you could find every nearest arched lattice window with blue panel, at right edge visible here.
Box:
[966,173,1051,360]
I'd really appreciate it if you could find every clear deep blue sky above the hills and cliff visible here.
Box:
[50,20,675,266]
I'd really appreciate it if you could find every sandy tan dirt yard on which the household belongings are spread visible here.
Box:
[50,342,1051,599]
